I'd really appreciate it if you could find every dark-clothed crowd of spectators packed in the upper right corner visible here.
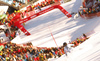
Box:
[79,0,100,15]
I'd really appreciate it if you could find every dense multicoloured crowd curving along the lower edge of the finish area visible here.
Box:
[0,34,88,61]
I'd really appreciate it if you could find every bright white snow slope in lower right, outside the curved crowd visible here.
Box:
[49,32,100,61]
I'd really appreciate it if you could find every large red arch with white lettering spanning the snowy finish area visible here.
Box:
[14,5,72,36]
